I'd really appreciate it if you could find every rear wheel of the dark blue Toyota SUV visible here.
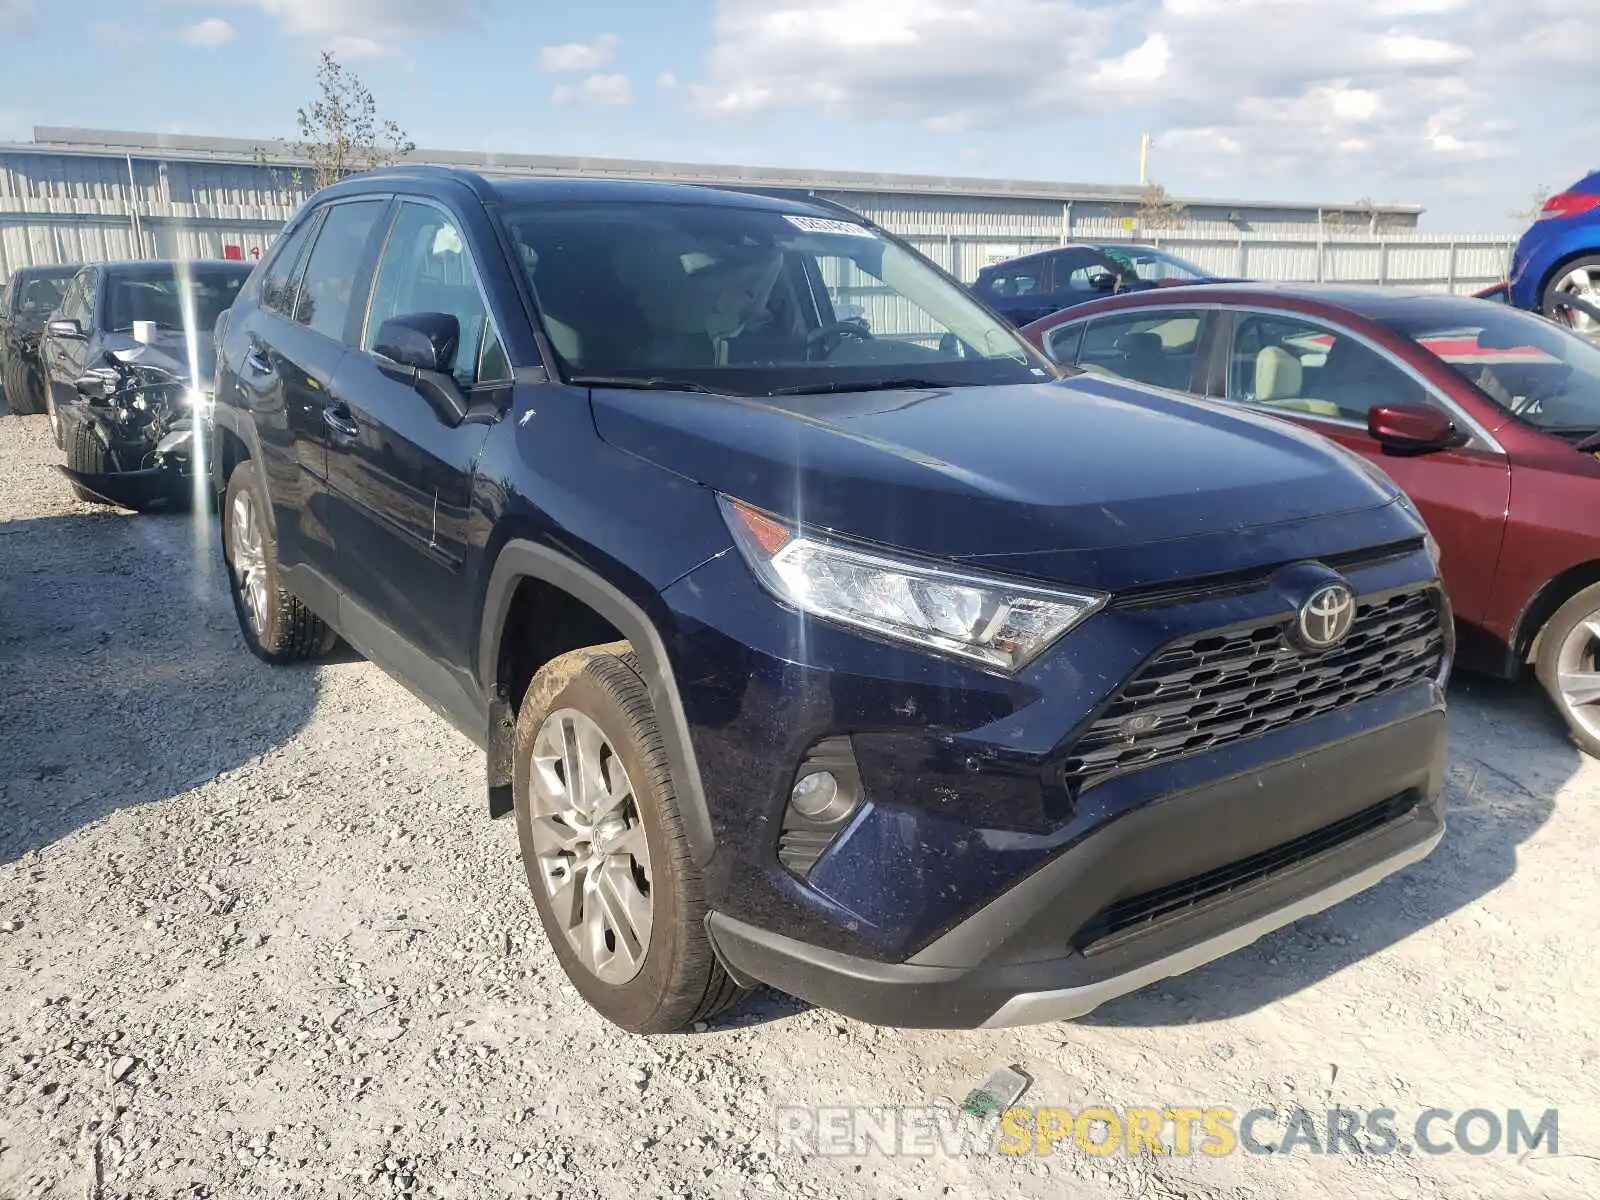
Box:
[221,459,339,666]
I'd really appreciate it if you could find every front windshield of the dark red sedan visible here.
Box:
[1379,301,1600,434]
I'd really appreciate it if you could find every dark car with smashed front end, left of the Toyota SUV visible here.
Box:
[43,262,251,510]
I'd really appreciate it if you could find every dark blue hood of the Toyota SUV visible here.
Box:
[592,378,1421,590]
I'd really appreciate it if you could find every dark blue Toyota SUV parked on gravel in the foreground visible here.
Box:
[210,168,1451,1032]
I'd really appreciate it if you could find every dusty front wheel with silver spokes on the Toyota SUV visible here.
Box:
[512,643,744,1034]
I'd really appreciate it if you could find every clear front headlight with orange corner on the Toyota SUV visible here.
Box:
[717,496,1106,672]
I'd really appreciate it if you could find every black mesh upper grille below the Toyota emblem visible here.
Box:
[1064,587,1445,789]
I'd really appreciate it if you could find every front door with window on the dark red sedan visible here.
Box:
[1227,312,1510,621]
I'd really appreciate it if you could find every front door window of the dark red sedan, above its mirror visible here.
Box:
[1227,317,1434,426]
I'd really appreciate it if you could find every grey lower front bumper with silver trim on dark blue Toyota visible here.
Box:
[707,704,1446,1029]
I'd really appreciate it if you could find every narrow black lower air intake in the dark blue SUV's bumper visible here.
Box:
[1072,792,1418,952]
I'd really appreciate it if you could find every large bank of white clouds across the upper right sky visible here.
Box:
[691,0,1600,188]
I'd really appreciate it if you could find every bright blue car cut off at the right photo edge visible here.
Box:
[1509,171,1600,333]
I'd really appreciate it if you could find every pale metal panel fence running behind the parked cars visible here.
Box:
[0,197,1515,293]
